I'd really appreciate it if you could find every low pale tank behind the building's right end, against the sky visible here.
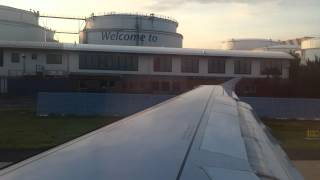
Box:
[222,39,280,50]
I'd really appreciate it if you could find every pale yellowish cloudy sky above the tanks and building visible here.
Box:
[0,0,320,48]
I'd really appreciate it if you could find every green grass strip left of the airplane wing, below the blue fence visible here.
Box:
[0,109,120,150]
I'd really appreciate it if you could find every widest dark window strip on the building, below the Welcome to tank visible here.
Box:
[79,53,139,71]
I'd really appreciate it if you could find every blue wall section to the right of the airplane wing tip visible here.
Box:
[240,97,320,120]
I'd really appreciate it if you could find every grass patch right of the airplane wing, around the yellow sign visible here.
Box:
[263,119,320,150]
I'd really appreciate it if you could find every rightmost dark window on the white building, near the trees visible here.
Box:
[260,60,282,75]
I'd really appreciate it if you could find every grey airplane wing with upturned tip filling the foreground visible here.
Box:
[0,80,303,180]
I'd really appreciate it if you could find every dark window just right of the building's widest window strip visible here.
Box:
[153,56,172,72]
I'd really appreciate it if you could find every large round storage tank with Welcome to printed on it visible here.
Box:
[80,14,183,47]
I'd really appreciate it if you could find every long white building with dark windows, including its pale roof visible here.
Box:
[0,42,292,93]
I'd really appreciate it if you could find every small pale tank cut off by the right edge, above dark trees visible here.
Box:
[301,38,320,64]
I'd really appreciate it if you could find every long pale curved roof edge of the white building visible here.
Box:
[0,41,293,59]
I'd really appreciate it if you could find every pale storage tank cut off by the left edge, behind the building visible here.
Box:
[0,6,54,41]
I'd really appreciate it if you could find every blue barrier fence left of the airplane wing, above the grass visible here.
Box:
[37,92,174,116]
